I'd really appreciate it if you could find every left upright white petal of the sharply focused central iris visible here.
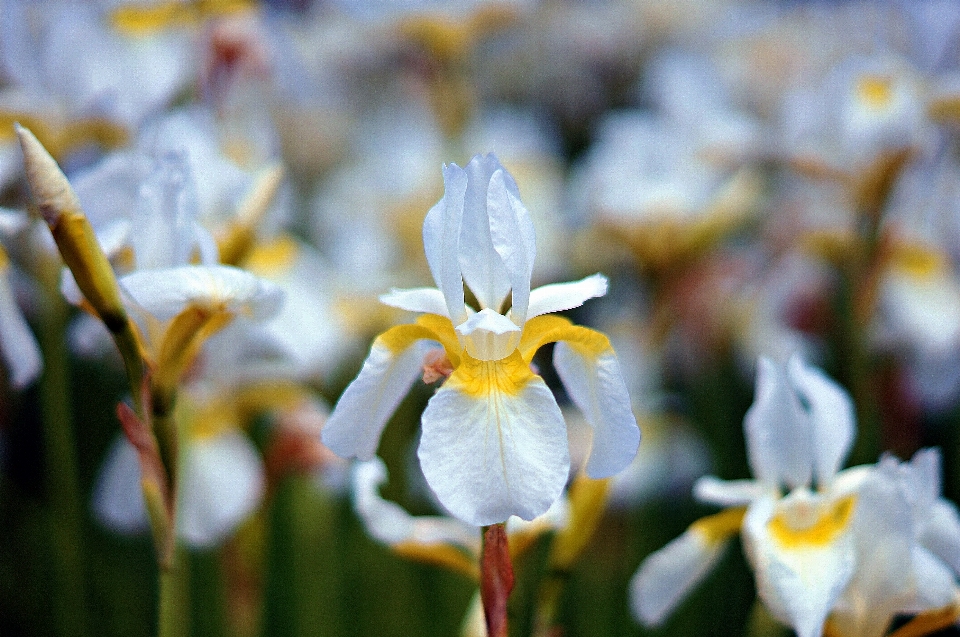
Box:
[423,164,467,325]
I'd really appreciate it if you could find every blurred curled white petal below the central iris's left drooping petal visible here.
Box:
[353,457,480,553]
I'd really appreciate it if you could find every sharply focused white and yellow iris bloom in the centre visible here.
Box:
[323,155,640,526]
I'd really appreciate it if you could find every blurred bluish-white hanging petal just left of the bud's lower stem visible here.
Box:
[92,436,148,534]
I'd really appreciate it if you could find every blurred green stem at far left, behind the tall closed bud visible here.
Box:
[39,260,90,636]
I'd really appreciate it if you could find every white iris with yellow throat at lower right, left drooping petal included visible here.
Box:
[631,357,868,637]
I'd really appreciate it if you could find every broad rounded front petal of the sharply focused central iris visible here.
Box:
[418,361,570,526]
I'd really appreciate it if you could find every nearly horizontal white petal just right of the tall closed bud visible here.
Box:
[120,265,283,320]
